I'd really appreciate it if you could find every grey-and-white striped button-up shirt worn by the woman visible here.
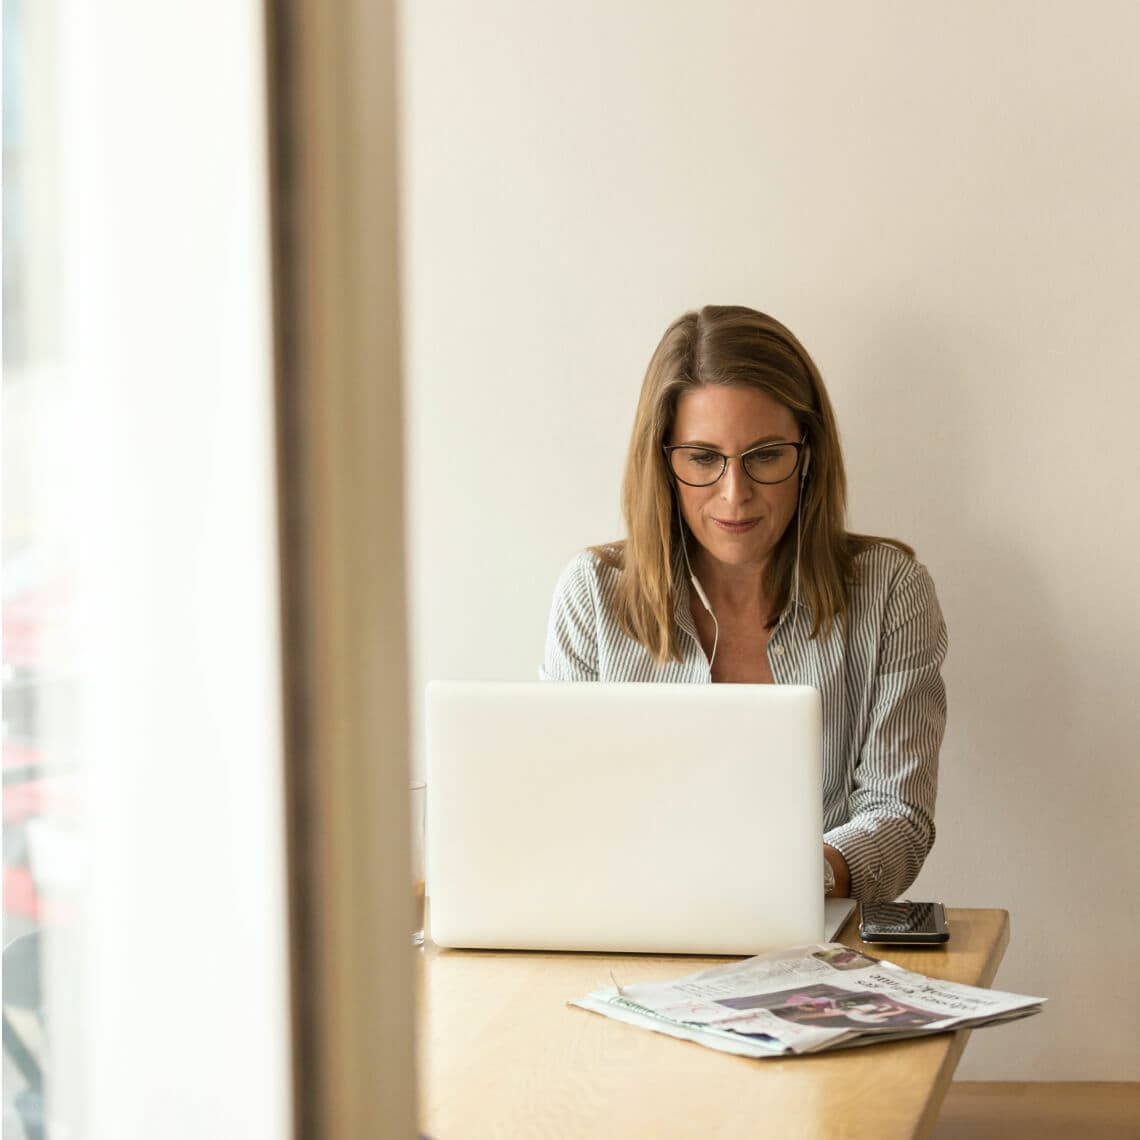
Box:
[539,544,946,899]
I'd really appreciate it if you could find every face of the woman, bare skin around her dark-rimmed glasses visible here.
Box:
[666,384,801,579]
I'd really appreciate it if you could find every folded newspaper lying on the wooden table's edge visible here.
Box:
[569,942,1045,1057]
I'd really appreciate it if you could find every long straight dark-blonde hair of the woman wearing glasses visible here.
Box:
[594,306,914,661]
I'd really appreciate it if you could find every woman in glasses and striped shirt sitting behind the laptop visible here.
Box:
[542,306,946,899]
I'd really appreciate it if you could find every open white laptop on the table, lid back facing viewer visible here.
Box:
[426,682,853,954]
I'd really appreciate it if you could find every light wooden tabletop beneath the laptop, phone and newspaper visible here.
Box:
[416,910,1009,1140]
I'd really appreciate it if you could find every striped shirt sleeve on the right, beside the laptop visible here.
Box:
[823,562,946,901]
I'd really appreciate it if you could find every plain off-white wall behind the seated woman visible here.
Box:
[404,0,1140,1080]
